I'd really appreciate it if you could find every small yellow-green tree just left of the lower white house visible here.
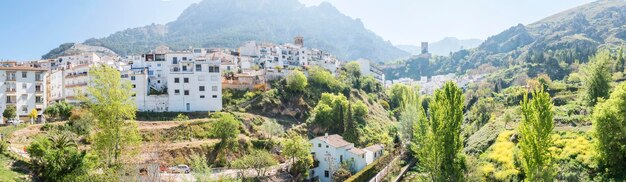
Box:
[283,133,313,181]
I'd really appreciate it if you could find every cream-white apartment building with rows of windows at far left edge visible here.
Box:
[0,66,46,122]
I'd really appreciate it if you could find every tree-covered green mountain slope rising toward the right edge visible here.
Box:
[385,0,626,79]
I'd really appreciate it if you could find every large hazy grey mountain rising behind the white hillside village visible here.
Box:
[70,0,409,61]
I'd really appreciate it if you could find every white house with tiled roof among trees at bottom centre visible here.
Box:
[309,134,384,182]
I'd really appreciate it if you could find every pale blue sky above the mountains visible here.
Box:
[0,0,591,60]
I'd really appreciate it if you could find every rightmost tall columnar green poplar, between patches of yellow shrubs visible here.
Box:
[519,89,554,181]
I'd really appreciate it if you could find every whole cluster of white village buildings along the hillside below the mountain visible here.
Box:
[0,37,385,122]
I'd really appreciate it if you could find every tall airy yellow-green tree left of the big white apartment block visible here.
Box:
[81,65,140,166]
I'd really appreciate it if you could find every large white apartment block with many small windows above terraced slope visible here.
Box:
[122,49,222,112]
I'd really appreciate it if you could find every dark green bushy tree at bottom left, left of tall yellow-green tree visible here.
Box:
[26,134,88,181]
